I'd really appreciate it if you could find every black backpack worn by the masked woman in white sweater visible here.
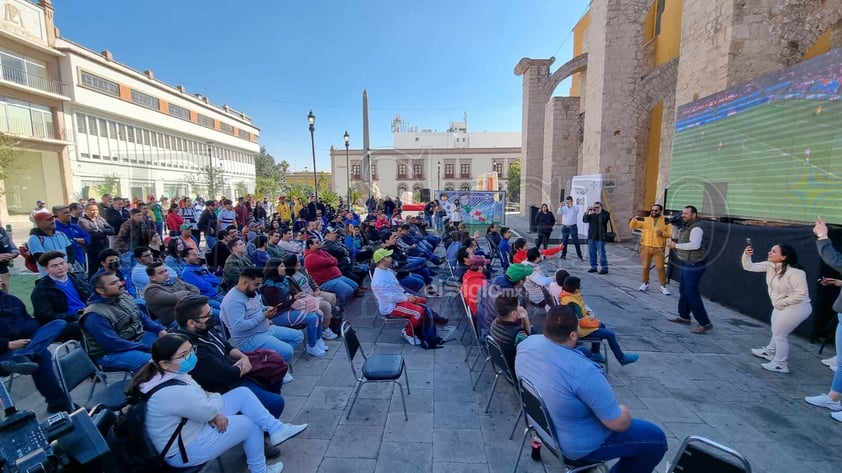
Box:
[107,379,187,473]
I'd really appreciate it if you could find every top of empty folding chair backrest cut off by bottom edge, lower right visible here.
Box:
[667,435,751,473]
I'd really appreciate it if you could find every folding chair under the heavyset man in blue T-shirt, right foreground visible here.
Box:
[512,377,604,473]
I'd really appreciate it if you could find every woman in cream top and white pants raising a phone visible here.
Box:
[743,245,813,373]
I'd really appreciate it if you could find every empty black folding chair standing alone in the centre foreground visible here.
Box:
[342,320,410,420]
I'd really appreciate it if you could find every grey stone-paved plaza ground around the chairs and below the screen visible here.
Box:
[3,212,842,473]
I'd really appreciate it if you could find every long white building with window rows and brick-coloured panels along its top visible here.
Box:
[56,39,260,200]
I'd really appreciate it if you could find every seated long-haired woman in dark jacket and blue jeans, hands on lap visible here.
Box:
[261,258,328,357]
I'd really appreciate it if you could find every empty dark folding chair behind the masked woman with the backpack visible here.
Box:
[53,340,129,412]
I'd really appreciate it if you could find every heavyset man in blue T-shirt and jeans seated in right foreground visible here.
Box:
[515,306,667,473]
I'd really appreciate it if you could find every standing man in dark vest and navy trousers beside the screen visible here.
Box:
[667,205,713,334]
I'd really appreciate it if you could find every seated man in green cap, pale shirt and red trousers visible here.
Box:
[371,248,436,346]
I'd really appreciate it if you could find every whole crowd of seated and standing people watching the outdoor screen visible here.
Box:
[0,189,842,472]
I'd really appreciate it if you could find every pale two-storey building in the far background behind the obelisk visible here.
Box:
[330,116,521,203]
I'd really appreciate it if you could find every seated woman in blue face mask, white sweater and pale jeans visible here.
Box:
[127,334,289,473]
